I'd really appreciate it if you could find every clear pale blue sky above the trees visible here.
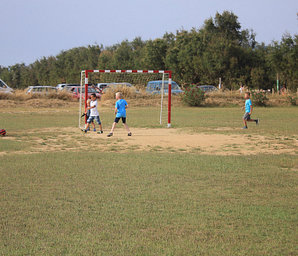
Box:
[0,0,298,67]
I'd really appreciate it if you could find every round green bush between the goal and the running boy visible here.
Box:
[180,85,205,107]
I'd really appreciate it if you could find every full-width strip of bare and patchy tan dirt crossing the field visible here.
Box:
[0,126,298,155]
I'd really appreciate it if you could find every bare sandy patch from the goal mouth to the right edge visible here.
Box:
[78,127,298,155]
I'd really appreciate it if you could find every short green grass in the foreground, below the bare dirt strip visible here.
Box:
[0,151,298,255]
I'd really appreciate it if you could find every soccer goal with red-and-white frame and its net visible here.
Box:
[79,70,172,129]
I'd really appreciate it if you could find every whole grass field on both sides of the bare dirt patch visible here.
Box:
[0,101,298,255]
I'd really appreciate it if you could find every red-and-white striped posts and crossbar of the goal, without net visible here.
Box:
[79,70,172,128]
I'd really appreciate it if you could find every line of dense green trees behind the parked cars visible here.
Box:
[0,11,298,91]
